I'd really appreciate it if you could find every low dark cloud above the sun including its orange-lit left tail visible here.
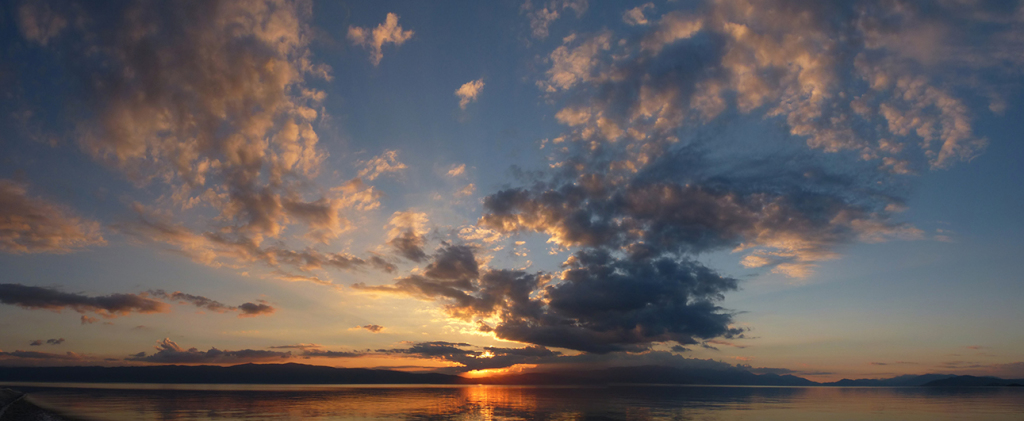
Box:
[353,246,741,352]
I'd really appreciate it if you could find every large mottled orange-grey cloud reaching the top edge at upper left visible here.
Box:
[56,0,330,242]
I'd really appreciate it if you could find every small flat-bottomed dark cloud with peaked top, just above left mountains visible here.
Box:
[125,338,292,364]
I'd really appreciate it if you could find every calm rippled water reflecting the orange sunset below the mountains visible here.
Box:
[9,383,1024,421]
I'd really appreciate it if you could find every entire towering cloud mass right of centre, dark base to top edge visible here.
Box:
[353,0,1019,355]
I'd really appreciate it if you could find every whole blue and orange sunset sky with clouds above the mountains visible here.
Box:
[0,0,1024,381]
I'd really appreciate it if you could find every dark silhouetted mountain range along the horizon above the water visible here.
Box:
[0,363,1024,387]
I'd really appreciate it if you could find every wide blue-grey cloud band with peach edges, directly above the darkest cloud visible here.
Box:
[479,159,920,277]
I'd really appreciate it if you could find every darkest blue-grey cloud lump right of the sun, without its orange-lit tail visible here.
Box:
[495,250,742,352]
